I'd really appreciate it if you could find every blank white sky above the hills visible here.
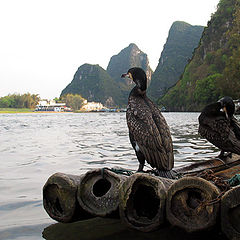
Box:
[0,0,219,98]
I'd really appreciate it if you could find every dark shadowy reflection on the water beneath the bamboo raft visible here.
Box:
[43,218,227,240]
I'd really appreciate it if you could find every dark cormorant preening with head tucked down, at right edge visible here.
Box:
[198,97,240,159]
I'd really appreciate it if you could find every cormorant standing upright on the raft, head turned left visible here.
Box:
[122,67,174,178]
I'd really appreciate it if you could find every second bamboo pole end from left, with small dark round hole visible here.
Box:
[77,169,126,217]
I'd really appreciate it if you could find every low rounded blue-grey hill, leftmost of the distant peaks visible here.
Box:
[61,64,121,106]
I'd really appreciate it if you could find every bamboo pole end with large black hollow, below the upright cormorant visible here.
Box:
[119,173,174,232]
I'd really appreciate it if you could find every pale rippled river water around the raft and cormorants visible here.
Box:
[0,113,217,240]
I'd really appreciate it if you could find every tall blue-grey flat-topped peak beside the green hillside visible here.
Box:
[148,21,204,100]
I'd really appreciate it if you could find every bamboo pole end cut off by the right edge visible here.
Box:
[221,186,240,240]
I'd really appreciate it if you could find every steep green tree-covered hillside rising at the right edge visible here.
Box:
[159,0,240,111]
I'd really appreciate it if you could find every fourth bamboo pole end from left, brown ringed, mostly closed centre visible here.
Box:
[166,177,220,232]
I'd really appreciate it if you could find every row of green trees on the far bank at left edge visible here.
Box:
[0,93,40,109]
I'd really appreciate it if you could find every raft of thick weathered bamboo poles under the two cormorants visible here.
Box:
[43,154,240,240]
